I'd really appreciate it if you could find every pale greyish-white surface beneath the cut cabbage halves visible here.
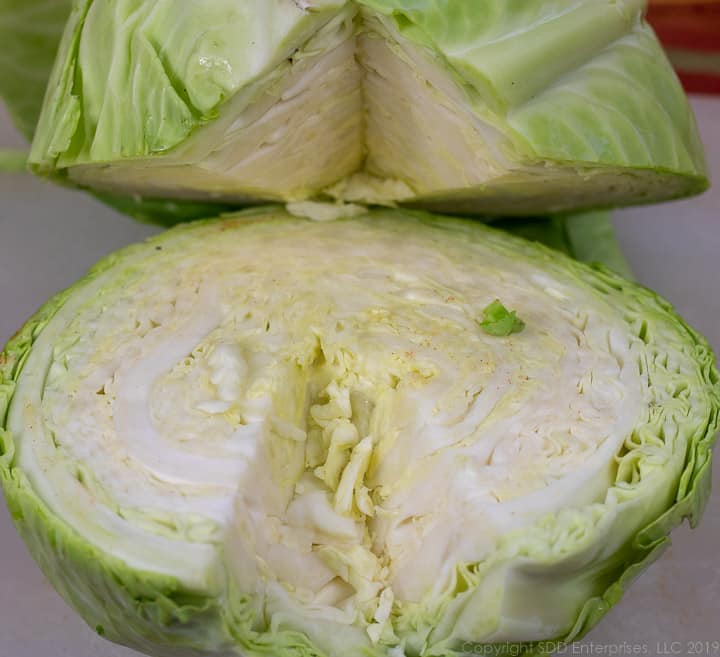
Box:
[0,98,720,657]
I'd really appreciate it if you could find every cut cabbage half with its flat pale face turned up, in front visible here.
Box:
[0,208,720,657]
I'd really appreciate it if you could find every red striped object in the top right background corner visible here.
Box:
[647,0,720,94]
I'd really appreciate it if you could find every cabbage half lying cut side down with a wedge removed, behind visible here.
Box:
[30,0,707,215]
